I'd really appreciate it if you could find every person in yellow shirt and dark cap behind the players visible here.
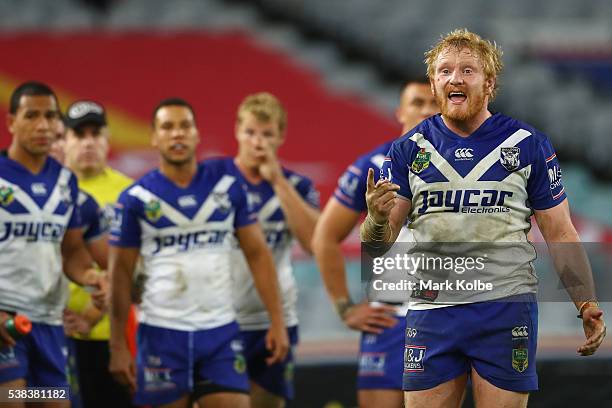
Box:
[64,101,132,408]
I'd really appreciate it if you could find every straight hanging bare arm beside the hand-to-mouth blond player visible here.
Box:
[236,223,289,364]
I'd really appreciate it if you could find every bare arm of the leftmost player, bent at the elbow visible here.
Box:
[62,228,108,308]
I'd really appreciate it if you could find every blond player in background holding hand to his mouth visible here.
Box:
[226,92,319,408]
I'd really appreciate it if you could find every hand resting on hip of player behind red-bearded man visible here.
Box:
[343,302,397,334]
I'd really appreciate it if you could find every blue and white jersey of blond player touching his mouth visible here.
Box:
[224,158,319,330]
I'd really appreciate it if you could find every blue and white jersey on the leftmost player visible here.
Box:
[0,154,81,325]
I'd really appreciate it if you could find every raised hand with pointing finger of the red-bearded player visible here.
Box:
[360,169,412,243]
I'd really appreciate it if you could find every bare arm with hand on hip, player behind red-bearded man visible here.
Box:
[312,197,397,333]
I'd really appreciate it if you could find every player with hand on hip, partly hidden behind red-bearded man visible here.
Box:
[312,78,439,408]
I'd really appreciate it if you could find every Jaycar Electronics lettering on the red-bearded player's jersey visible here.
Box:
[418,190,512,214]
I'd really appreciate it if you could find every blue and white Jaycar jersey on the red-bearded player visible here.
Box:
[382,113,566,309]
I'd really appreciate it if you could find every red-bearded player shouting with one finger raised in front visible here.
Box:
[361,30,605,407]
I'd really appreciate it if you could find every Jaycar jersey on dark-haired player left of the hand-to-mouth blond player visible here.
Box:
[110,160,257,331]
